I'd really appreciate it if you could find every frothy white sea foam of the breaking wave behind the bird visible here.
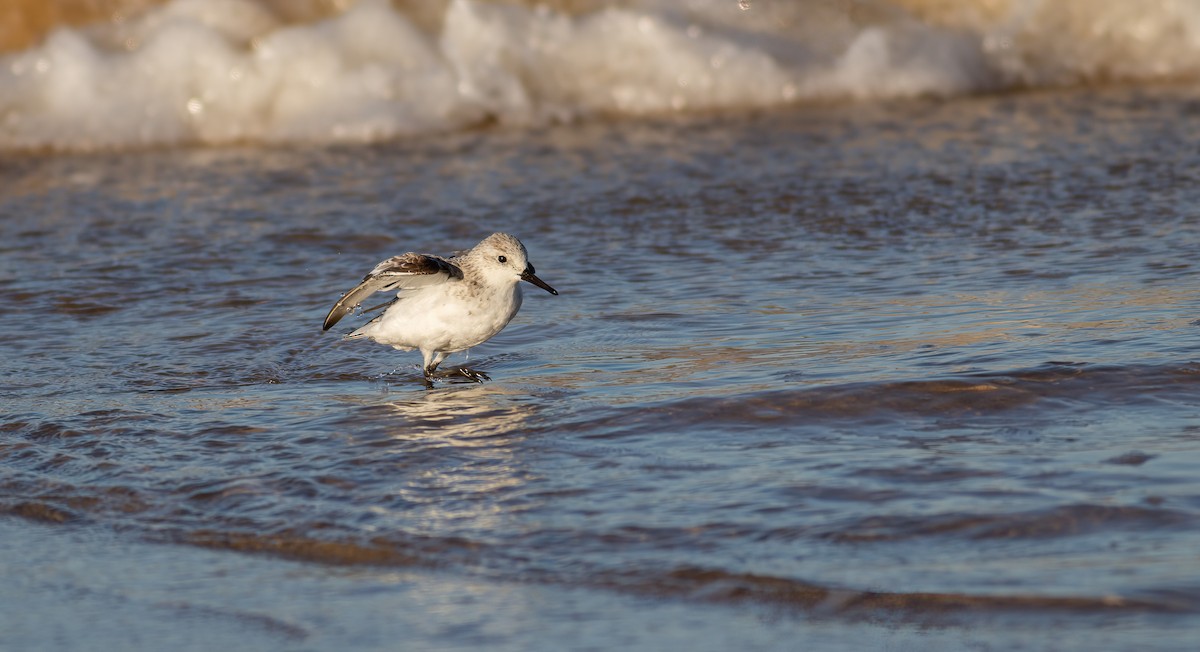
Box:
[0,0,1200,149]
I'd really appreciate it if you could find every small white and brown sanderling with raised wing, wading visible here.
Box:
[322,233,558,381]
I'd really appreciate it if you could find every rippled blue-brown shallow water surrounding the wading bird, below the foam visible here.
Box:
[0,86,1200,650]
